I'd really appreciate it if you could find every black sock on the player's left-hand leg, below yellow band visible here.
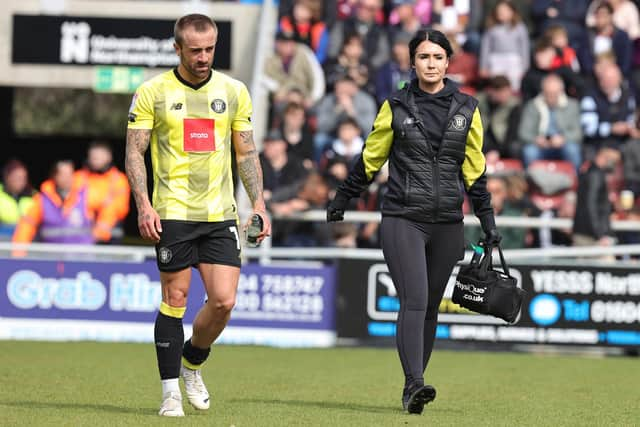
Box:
[154,312,184,380]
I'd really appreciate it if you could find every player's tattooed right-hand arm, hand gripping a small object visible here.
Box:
[231,131,271,241]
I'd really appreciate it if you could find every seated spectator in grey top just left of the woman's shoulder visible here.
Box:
[314,76,377,160]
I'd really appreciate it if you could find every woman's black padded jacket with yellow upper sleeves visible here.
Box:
[336,80,495,232]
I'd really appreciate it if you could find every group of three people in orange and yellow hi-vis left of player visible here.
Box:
[0,141,130,249]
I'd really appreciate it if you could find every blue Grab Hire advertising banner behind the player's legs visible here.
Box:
[0,259,335,346]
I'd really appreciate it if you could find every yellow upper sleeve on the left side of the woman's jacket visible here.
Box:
[362,101,393,181]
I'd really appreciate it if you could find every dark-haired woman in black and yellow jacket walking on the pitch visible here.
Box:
[327,30,500,414]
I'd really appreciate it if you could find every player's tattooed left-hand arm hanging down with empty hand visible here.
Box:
[124,129,162,242]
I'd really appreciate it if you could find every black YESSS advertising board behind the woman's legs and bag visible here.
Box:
[336,260,640,347]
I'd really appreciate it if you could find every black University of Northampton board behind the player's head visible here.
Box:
[11,15,232,70]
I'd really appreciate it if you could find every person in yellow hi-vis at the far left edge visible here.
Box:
[0,159,35,240]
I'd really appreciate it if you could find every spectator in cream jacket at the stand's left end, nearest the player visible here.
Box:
[264,31,315,111]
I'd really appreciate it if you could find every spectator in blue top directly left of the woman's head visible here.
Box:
[375,32,413,104]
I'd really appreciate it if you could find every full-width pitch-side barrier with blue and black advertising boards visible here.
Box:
[0,212,640,352]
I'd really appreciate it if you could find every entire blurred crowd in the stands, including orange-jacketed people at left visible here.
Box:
[0,0,640,248]
